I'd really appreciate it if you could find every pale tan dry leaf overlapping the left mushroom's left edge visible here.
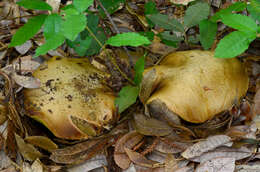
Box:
[12,73,41,88]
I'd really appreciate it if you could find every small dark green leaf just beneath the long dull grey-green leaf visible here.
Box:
[159,31,183,47]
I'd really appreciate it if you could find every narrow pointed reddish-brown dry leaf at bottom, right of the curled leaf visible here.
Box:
[125,147,161,168]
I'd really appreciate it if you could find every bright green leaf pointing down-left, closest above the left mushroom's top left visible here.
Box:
[34,35,65,57]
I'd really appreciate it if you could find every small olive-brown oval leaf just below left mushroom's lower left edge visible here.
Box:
[24,136,58,152]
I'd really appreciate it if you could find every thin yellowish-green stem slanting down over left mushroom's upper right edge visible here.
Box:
[86,26,134,85]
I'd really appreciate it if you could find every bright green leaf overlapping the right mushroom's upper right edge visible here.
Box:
[215,31,256,58]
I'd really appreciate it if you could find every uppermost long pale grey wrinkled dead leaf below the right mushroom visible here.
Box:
[181,135,231,159]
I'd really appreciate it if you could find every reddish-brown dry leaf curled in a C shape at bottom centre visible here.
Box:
[114,131,143,169]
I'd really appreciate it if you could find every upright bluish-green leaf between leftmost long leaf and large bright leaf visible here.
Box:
[43,14,62,40]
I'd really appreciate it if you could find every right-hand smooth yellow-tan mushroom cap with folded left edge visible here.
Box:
[140,50,249,124]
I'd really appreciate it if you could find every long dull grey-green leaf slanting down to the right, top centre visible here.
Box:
[146,13,184,32]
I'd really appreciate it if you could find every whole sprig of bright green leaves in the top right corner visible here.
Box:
[199,0,260,58]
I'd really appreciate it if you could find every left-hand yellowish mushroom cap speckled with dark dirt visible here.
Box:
[24,57,116,139]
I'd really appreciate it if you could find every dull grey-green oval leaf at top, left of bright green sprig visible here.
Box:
[184,2,210,28]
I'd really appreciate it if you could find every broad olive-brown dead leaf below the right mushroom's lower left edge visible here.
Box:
[134,114,172,136]
